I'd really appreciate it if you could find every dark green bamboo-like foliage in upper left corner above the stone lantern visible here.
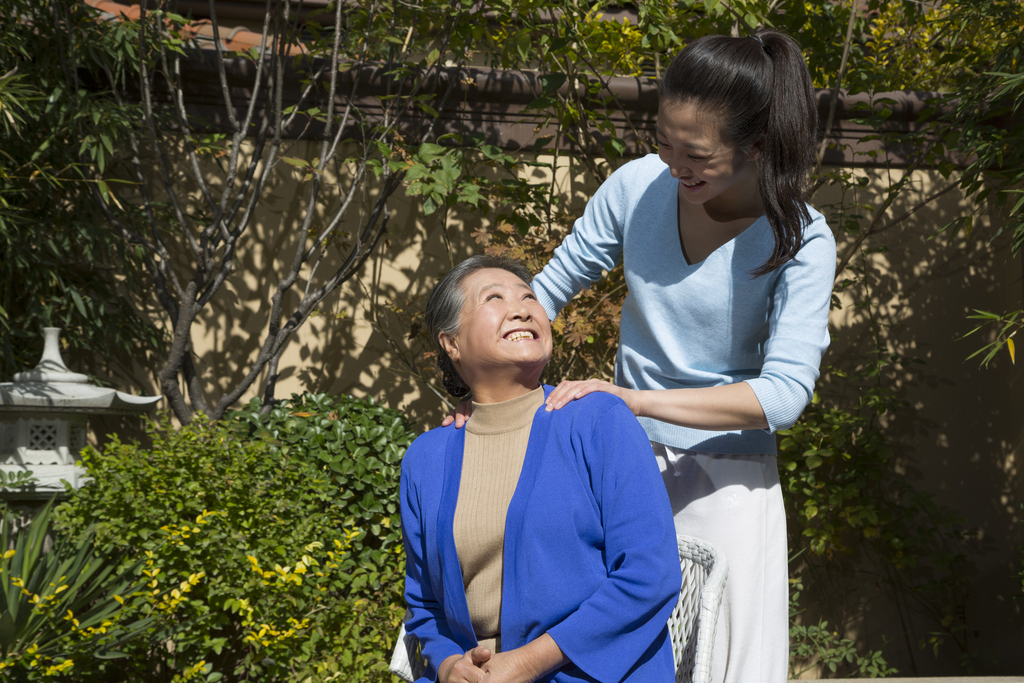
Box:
[0,0,163,380]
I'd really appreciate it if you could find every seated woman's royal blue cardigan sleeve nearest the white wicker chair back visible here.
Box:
[548,403,682,681]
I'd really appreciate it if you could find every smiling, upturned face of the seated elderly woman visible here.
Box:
[442,268,551,386]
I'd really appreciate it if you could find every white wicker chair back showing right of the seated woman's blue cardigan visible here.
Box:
[669,535,729,683]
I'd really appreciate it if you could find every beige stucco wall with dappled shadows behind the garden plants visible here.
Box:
[123,143,1024,675]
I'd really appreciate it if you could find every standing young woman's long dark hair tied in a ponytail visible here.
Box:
[659,31,818,276]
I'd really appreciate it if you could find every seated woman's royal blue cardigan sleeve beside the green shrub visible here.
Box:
[399,444,464,681]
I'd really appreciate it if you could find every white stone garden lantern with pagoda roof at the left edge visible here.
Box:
[0,328,161,499]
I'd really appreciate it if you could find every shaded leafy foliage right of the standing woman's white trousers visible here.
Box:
[778,369,972,667]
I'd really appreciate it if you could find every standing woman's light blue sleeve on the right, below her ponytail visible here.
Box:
[748,215,836,432]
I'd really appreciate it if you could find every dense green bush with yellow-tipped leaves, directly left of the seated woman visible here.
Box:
[57,396,410,683]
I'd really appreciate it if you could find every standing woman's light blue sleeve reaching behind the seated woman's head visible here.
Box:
[531,167,626,319]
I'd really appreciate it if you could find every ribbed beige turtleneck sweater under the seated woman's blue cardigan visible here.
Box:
[454,387,544,652]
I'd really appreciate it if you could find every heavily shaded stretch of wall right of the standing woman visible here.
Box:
[807,167,1024,676]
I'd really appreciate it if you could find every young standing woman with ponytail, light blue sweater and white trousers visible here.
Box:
[446,31,836,683]
